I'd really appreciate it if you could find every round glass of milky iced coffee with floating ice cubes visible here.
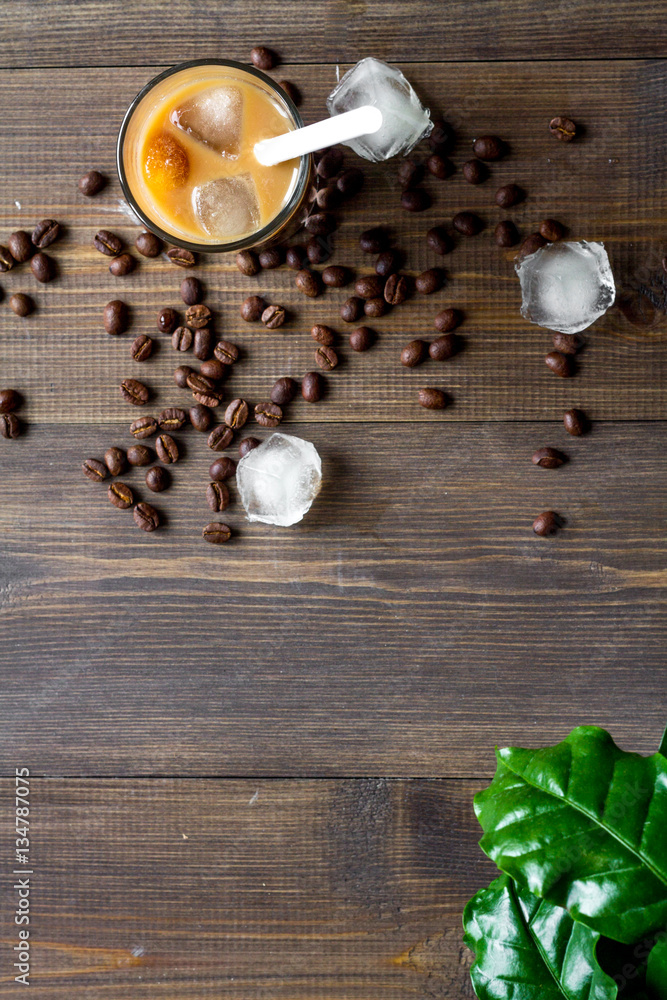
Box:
[117,59,312,253]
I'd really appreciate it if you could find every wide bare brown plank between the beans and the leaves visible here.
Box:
[0,423,667,777]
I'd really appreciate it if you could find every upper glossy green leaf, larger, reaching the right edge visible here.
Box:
[475,726,667,944]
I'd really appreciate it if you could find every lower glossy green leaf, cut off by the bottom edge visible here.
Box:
[463,875,618,1000]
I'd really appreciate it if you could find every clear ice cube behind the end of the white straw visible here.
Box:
[327,56,433,162]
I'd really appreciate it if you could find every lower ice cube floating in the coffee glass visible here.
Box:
[192,174,259,241]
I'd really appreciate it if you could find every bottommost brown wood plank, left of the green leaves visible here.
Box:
[0,779,494,1000]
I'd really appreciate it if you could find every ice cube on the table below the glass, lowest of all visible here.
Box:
[236,434,322,527]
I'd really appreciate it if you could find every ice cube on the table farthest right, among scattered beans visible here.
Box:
[516,240,616,333]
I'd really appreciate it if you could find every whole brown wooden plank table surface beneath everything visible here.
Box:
[0,0,667,1000]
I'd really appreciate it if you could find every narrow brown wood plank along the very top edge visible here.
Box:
[0,0,667,67]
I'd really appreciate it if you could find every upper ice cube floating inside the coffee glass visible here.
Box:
[171,87,243,157]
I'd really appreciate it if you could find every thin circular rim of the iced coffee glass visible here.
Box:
[116,59,310,253]
